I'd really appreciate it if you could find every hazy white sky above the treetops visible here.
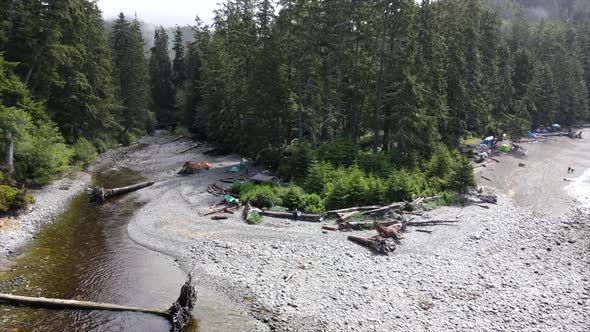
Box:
[98,0,223,26]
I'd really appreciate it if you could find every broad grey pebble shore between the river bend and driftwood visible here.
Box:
[111,138,590,331]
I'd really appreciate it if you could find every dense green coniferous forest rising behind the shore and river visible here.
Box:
[0,0,590,205]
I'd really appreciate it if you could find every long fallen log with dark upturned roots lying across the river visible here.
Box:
[0,273,197,332]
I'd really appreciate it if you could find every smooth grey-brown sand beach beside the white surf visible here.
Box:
[476,129,590,216]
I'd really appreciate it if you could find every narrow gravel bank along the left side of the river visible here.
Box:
[0,172,91,257]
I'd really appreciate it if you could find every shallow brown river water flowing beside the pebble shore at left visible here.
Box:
[0,169,197,332]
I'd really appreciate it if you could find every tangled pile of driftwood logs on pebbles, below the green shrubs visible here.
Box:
[322,195,497,255]
